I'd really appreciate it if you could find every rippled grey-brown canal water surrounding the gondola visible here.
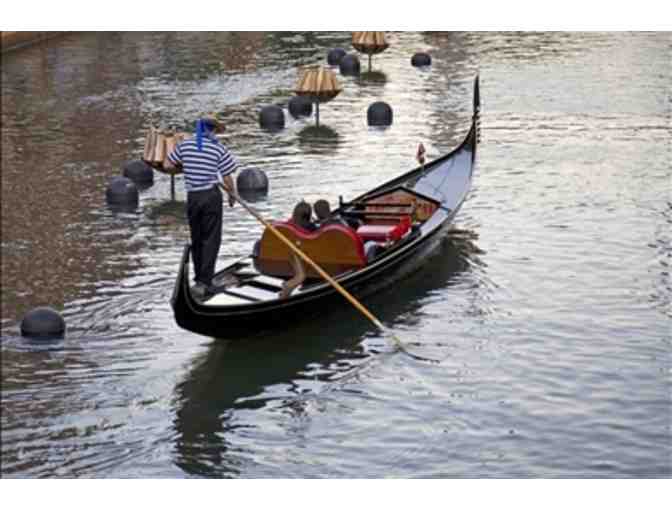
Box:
[1,32,672,478]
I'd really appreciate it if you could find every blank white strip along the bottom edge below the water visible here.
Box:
[0,480,669,510]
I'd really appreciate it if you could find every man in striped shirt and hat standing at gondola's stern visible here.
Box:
[168,115,238,295]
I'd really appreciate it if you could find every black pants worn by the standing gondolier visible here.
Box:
[187,188,222,285]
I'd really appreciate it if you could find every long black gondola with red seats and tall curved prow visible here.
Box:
[171,76,480,339]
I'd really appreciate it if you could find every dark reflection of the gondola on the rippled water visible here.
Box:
[173,232,480,476]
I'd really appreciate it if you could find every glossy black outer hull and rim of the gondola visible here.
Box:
[171,76,480,334]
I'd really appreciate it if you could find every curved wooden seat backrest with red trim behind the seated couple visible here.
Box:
[255,222,366,277]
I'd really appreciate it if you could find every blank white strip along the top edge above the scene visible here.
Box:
[0,0,672,31]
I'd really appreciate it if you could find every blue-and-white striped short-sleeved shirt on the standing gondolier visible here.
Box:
[168,136,238,192]
